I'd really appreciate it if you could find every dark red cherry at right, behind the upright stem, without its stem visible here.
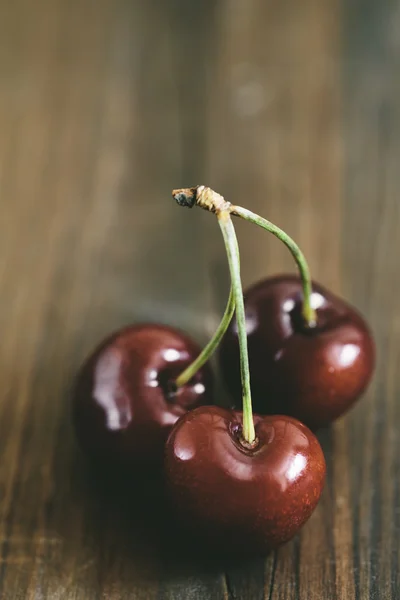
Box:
[219,275,375,429]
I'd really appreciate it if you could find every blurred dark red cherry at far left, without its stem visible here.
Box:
[73,325,212,466]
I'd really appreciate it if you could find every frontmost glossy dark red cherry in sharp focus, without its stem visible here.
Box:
[165,406,326,554]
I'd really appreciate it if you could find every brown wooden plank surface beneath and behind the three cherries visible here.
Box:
[0,0,400,600]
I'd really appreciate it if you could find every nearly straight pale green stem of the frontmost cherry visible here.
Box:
[217,210,256,444]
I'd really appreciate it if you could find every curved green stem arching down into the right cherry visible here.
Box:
[230,205,317,329]
